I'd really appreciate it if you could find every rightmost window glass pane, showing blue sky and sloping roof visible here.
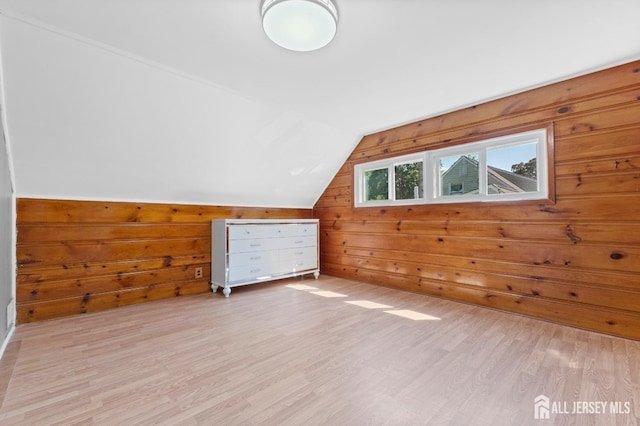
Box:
[487,142,538,195]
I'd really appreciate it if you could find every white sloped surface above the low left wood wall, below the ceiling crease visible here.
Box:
[2,18,358,208]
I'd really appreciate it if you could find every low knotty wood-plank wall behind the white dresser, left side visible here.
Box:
[16,198,312,324]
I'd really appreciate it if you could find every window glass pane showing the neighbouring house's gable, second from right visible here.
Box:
[438,152,480,197]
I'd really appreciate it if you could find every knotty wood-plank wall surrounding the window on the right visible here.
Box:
[314,62,640,339]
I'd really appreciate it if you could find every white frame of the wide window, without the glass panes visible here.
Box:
[354,127,552,207]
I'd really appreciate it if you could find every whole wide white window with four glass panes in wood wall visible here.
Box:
[354,129,550,207]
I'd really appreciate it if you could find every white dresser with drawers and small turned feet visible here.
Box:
[211,219,320,297]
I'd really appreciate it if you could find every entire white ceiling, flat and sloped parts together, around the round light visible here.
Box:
[0,0,640,207]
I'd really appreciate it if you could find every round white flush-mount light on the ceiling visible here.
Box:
[261,0,338,52]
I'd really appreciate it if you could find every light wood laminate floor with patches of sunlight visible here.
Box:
[0,276,640,425]
